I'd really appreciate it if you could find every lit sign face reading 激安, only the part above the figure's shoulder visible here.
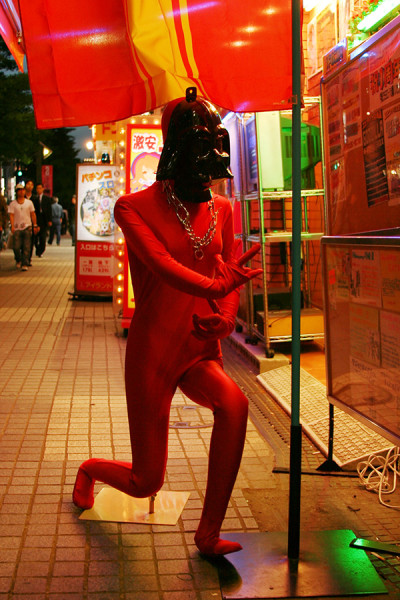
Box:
[126,124,163,194]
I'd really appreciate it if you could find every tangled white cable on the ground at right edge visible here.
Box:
[357,446,400,510]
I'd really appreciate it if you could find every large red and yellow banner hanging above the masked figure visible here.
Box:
[9,0,291,128]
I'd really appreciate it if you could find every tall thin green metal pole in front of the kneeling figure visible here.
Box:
[288,0,302,559]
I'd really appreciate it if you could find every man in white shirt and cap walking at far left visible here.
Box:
[8,183,39,271]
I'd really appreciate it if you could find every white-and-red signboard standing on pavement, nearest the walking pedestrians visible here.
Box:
[74,164,121,296]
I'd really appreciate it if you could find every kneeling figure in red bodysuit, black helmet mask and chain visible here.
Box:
[73,88,261,556]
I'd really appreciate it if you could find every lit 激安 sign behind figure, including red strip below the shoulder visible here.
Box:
[122,123,163,328]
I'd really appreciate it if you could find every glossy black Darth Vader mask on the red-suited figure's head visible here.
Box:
[157,88,233,202]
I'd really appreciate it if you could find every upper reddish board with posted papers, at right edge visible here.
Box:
[322,18,400,235]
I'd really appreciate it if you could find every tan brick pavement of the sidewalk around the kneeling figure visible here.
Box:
[0,238,400,600]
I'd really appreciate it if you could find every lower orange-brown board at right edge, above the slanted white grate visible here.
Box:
[322,237,400,443]
